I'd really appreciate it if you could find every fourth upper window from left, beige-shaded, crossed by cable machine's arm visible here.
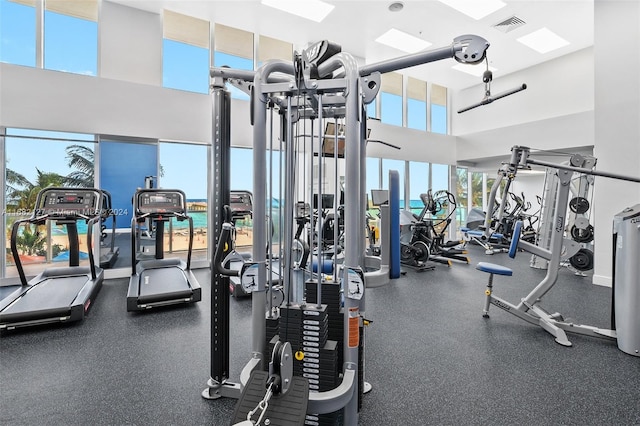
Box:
[213,24,253,100]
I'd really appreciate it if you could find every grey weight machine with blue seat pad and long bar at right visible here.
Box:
[477,146,640,356]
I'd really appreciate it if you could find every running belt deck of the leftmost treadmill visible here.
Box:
[0,275,88,322]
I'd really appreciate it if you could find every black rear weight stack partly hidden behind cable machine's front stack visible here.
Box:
[305,280,344,369]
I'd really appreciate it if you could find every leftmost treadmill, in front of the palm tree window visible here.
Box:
[0,187,104,331]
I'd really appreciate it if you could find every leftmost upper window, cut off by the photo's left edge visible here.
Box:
[0,0,36,67]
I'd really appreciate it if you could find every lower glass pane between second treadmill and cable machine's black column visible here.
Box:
[159,142,208,260]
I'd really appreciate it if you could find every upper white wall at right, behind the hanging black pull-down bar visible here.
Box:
[452,48,594,168]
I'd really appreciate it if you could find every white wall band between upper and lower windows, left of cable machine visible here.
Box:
[0,63,211,142]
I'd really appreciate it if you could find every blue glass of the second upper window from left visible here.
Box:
[44,11,98,75]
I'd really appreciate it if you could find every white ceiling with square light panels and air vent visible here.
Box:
[110,0,594,89]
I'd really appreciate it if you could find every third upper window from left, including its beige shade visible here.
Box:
[162,10,210,93]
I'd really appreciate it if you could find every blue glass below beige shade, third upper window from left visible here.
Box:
[162,39,209,93]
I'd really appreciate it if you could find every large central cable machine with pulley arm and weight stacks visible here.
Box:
[202,35,489,425]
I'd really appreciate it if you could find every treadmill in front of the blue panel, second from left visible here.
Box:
[127,189,202,312]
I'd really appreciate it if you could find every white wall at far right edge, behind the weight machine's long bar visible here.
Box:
[593,0,640,285]
